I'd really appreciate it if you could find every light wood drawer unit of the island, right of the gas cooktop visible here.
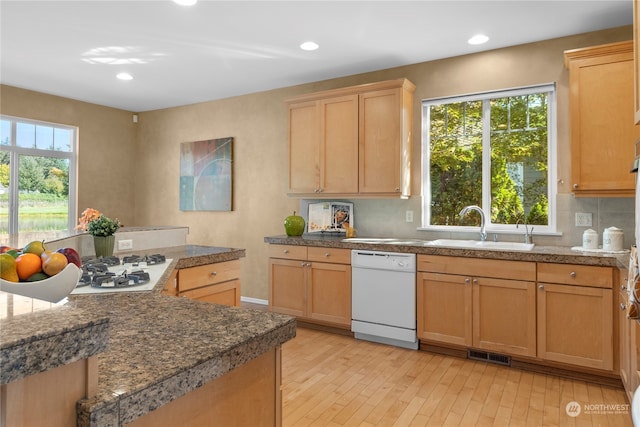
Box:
[162,260,240,307]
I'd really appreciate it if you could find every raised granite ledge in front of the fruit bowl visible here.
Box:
[0,292,109,384]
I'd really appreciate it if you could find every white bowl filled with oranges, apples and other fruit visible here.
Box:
[0,241,82,303]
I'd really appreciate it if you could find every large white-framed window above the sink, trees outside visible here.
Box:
[422,84,556,232]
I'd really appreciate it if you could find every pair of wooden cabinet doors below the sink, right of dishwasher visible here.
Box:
[417,261,536,356]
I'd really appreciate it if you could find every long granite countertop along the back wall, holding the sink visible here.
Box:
[264,235,629,267]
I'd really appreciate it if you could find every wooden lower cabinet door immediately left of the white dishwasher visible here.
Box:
[307,262,351,328]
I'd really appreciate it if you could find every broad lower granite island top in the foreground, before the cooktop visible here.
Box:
[77,292,296,427]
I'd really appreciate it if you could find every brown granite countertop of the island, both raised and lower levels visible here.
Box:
[0,245,296,427]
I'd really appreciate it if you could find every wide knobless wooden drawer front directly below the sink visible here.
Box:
[418,255,536,281]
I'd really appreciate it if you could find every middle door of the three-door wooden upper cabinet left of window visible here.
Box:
[319,94,358,193]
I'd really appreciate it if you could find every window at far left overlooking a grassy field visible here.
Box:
[0,116,77,245]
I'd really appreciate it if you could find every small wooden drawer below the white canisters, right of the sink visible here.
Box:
[538,263,613,289]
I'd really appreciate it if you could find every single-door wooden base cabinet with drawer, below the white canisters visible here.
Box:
[538,263,614,371]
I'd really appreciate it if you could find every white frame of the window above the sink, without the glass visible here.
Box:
[418,83,558,235]
